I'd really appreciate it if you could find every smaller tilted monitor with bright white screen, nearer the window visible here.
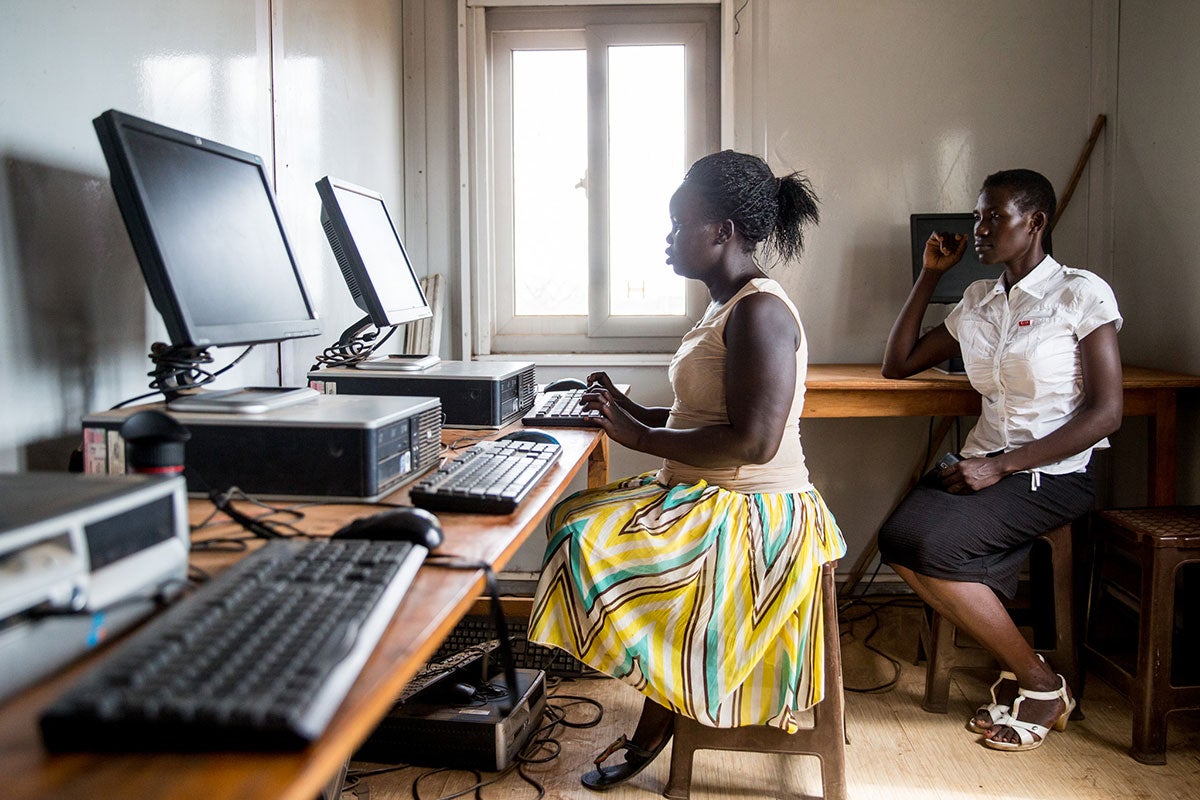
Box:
[317,175,437,368]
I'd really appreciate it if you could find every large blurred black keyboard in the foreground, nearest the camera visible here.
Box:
[41,540,426,752]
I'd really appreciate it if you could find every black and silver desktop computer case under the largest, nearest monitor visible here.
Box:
[83,395,442,501]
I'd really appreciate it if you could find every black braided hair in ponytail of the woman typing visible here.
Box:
[684,150,821,260]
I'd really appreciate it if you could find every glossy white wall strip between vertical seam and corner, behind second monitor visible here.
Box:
[271,0,408,385]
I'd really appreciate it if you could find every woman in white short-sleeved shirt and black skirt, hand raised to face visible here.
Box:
[878,169,1122,750]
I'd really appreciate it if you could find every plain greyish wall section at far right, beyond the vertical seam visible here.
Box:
[1111,0,1200,504]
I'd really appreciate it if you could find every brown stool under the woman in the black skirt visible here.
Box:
[920,524,1084,718]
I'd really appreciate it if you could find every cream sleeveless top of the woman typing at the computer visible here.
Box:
[658,278,812,493]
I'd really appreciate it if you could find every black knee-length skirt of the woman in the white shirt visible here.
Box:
[878,470,1096,597]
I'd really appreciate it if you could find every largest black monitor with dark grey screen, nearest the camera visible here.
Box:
[92,110,322,410]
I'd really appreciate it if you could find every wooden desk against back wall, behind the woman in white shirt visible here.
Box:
[803,363,1200,505]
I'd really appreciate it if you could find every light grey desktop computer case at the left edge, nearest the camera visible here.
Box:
[0,473,190,699]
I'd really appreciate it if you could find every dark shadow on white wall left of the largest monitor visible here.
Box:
[0,155,149,468]
